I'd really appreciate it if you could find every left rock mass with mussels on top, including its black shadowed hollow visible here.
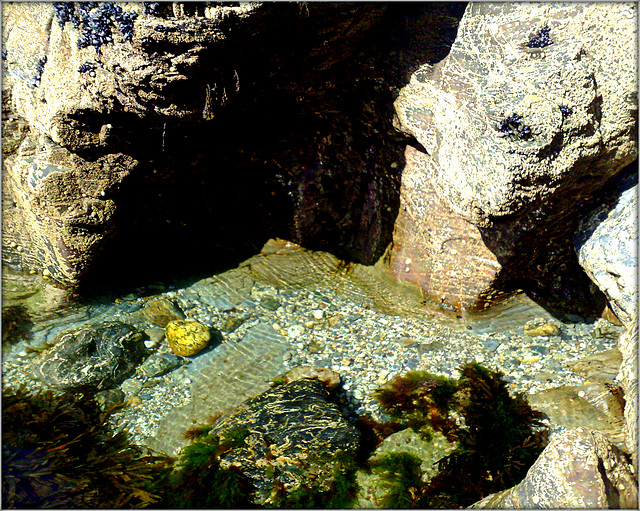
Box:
[3,3,444,296]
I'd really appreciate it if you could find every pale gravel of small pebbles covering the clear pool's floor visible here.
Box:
[3,283,616,452]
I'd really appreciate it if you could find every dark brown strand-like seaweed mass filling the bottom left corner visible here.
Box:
[2,387,172,508]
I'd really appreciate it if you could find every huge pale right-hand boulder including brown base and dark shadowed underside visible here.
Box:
[389,3,638,313]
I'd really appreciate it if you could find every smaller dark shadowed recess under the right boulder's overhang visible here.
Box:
[480,159,638,321]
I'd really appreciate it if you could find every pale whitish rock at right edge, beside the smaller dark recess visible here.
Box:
[575,179,638,325]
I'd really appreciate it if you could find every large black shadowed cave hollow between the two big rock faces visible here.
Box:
[80,2,466,295]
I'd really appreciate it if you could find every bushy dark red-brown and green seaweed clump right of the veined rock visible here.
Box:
[376,362,548,508]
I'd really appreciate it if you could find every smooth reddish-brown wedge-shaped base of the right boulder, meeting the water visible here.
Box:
[384,146,504,311]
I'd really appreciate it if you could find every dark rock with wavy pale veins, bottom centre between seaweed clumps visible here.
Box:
[210,379,360,505]
